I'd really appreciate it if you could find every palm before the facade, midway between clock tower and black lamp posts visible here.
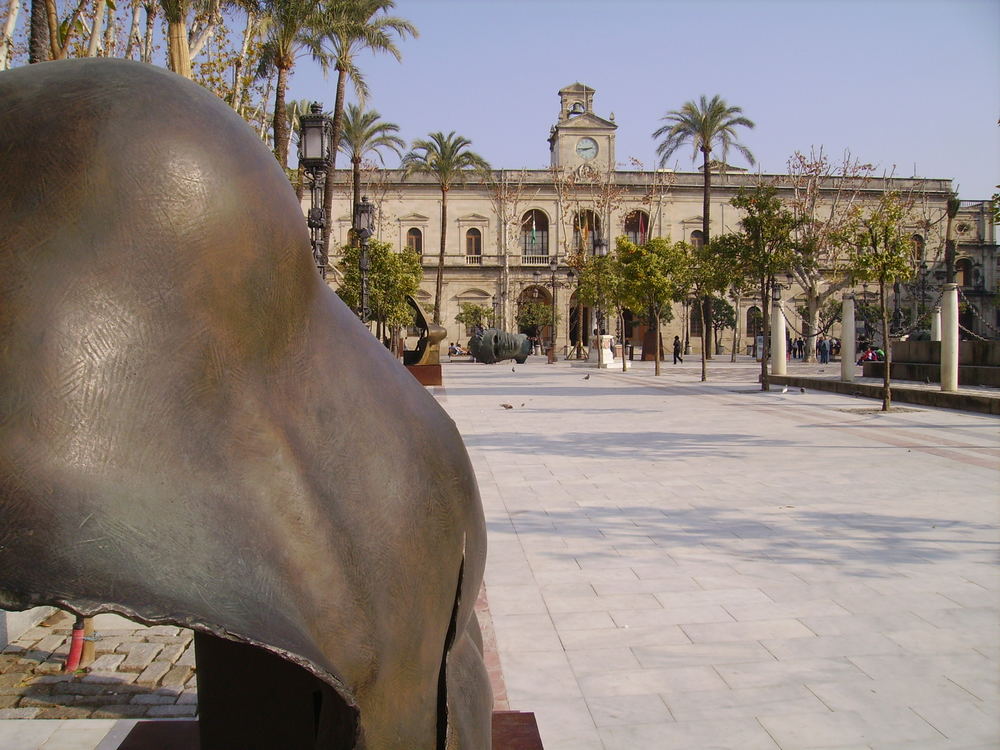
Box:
[402,130,490,324]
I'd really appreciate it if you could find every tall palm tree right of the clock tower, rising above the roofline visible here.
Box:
[653,94,754,359]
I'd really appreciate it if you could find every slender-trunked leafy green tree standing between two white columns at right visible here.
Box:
[844,191,913,411]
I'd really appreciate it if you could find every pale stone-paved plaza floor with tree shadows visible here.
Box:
[0,357,1000,750]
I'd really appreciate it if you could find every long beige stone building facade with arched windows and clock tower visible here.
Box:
[318,83,1000,353]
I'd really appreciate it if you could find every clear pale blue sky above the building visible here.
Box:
[289,0,1000,199]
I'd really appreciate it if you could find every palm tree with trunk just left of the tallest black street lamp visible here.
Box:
[260,0,329,169]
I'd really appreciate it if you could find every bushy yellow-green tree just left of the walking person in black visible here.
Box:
[617,237,687,375]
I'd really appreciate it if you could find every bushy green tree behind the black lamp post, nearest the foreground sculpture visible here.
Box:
[337,239,424,339]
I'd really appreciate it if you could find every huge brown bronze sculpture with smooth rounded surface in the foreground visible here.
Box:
[0,59,491,750]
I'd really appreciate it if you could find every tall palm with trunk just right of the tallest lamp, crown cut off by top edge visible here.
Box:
[322,0,418,262]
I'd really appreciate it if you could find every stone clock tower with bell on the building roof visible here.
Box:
[549,83,618,172]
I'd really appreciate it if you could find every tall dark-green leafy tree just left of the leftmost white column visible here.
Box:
[716,185,800,391]
